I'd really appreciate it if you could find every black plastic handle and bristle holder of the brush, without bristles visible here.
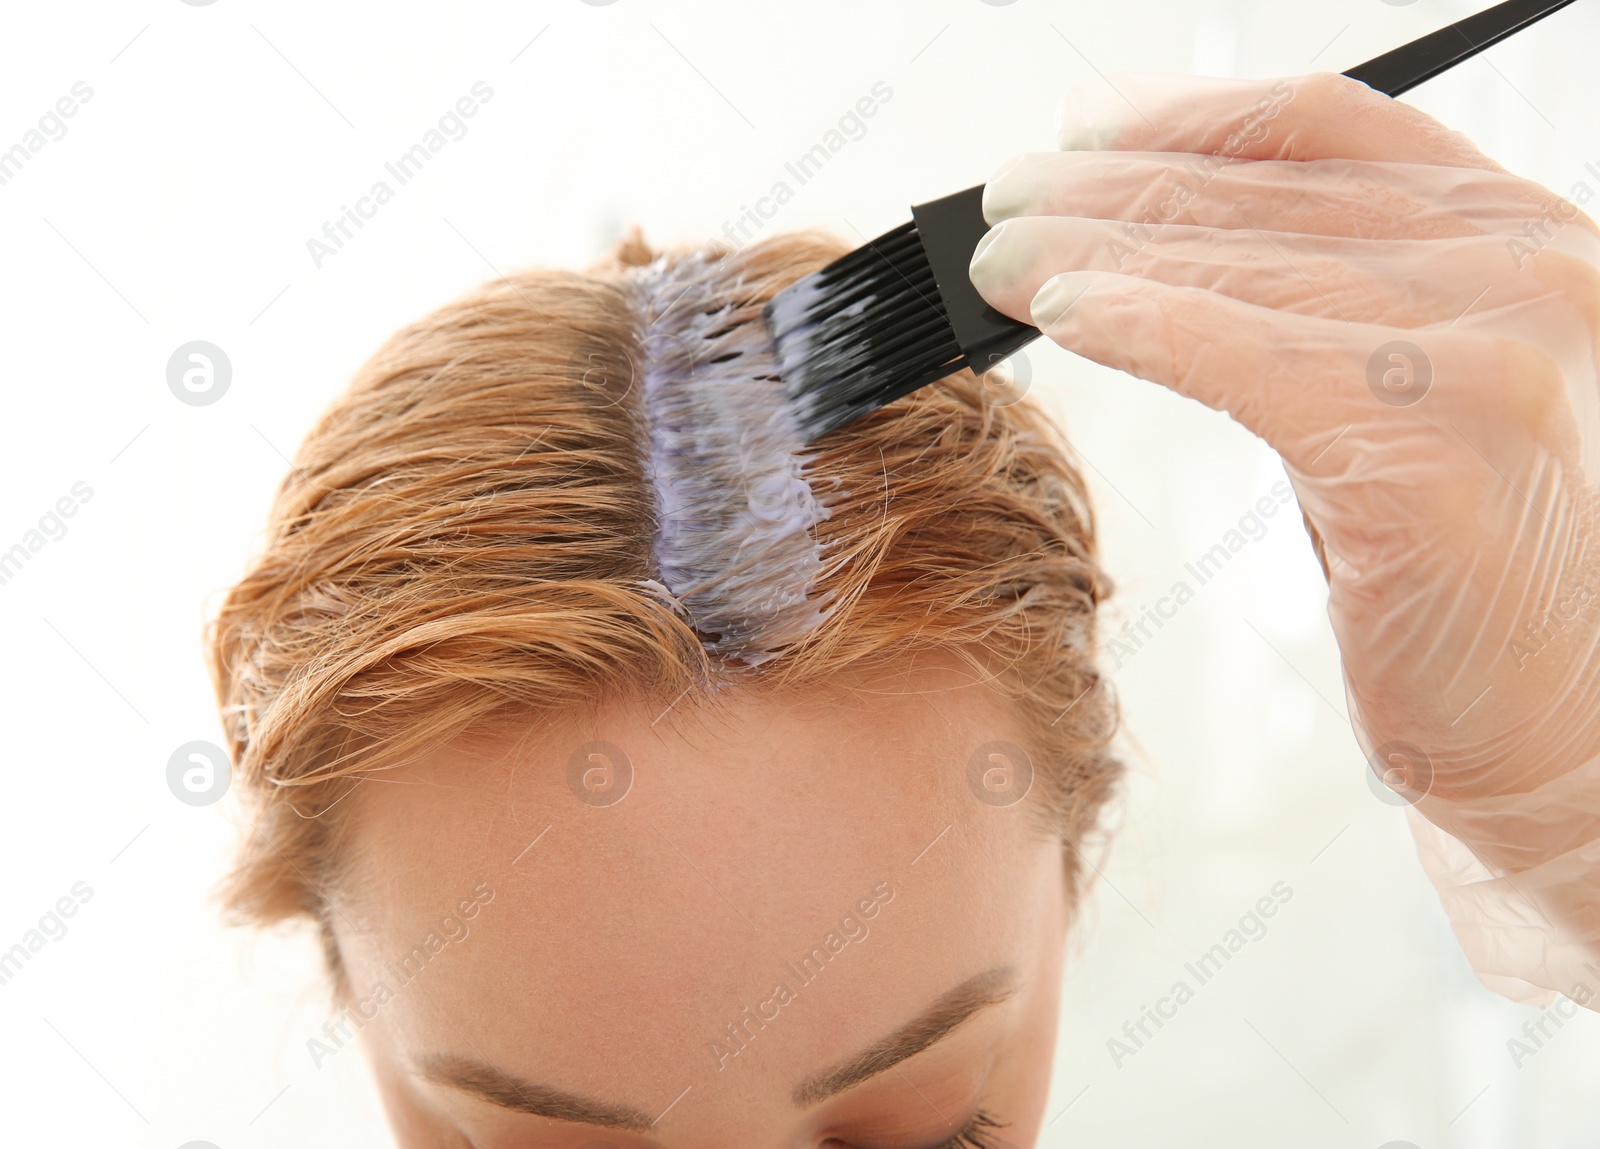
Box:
[934,0,1573,374]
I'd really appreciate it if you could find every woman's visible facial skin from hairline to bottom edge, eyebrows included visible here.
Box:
[334,666,1067,1149]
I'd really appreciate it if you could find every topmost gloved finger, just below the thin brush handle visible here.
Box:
[1056,72,1502,171]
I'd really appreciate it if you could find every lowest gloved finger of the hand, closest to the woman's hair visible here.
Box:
[1032,270,1499,473]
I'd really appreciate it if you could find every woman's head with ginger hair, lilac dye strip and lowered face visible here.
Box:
[211,228,1117,1149]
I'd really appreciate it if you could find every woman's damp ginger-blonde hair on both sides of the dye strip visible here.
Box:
[206,232,1122,984]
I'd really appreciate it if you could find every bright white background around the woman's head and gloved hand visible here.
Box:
[0,0,1600,1149]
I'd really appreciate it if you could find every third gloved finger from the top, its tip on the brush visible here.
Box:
[968,216,1574,328]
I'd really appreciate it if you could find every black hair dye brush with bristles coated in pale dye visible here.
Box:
[763,0,1573,442]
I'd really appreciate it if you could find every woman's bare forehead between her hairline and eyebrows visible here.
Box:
[336,669,1059,1095]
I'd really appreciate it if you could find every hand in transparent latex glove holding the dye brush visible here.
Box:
[971,74,1600,1008]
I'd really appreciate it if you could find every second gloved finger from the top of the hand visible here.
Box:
[984,152,1568,238]
